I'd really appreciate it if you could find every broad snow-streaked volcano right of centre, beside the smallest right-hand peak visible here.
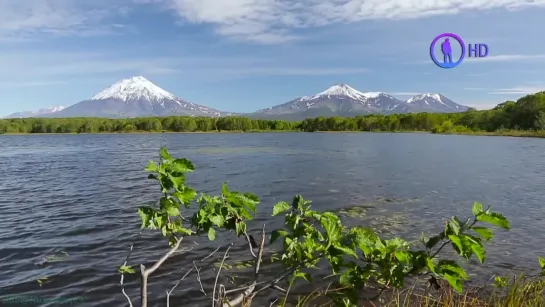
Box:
[251,84,407,120]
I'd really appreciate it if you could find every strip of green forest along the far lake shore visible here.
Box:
[0,92,545,133]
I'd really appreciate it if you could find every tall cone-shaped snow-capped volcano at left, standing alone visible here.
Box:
[42,76,227,117]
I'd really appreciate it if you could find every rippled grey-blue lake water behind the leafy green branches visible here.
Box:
[0,133,545,306]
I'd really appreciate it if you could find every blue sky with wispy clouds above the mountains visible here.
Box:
[0,0,545,116]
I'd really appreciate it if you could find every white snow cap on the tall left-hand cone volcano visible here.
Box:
[91,76,179,104]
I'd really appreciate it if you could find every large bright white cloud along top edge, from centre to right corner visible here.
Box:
[159,0,545,43]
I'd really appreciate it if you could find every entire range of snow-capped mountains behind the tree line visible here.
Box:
[6,76,468,120]
